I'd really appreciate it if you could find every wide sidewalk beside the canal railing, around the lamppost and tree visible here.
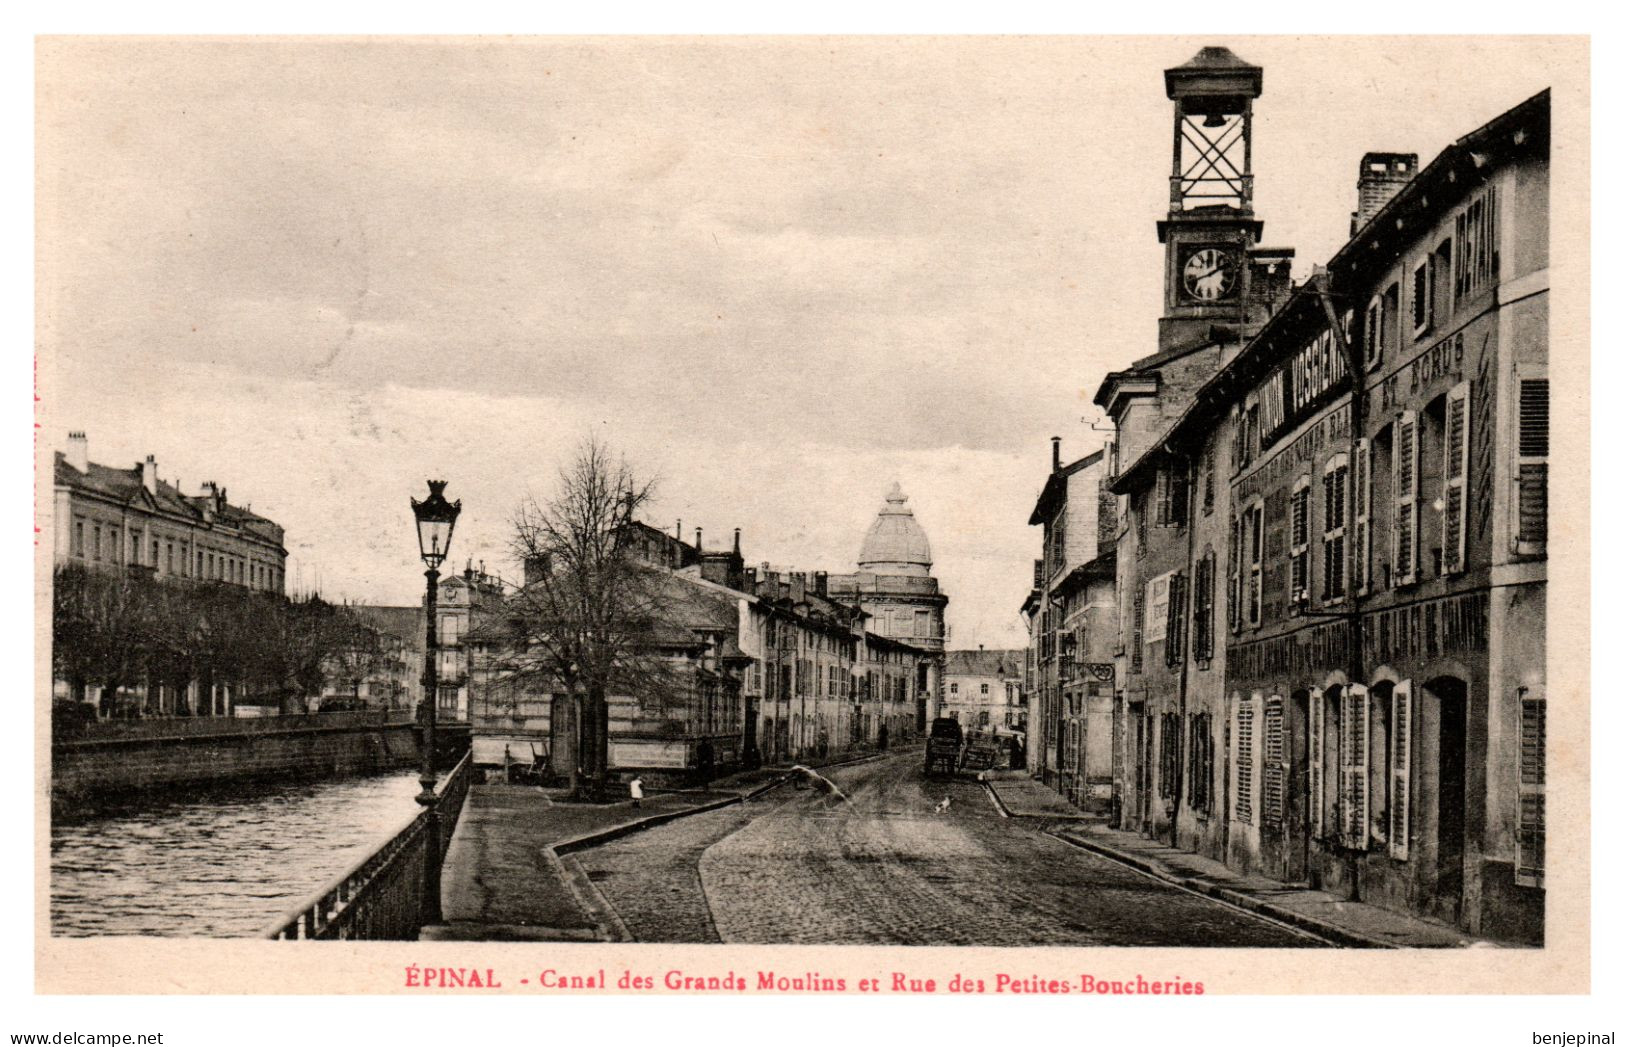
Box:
[421,754,873,941]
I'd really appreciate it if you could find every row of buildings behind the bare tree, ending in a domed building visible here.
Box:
[461,484,947,784]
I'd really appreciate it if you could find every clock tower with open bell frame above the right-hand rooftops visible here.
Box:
[1157,47,1264,353]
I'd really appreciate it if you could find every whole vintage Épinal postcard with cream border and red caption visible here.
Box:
[34,36,1591,998]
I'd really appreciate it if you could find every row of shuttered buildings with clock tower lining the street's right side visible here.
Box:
[1024,47,1550,941]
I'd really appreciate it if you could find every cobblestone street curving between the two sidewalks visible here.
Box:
[570,754,1323,948]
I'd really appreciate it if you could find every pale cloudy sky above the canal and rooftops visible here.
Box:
[37,37,1573,645]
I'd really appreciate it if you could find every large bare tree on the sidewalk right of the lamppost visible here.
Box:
[494,437,671,802]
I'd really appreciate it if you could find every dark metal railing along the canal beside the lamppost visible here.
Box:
[265,751,475,941]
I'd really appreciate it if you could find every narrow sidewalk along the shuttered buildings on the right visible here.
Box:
[985,779,1489,949]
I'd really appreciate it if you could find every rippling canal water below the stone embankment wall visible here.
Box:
[50,772,419,938]
